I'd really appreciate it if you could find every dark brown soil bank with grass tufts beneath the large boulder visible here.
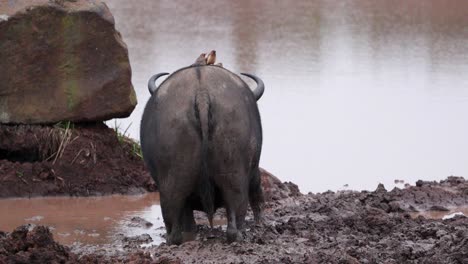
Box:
[0,122,156,198]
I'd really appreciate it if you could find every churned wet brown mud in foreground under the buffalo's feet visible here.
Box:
[0,177,468,263]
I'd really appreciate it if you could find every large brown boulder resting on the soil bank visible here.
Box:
[0,0,137,124]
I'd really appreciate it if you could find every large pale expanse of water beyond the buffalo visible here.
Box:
[107,0,468,192]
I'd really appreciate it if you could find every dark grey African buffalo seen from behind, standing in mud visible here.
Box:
[140,65,264,244]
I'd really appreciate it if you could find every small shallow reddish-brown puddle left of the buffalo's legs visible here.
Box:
[0,193,165,245]
